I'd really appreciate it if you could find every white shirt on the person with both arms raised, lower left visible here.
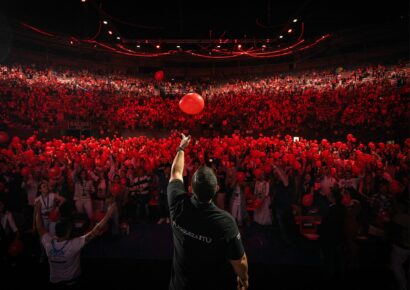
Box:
[41,233,85,283]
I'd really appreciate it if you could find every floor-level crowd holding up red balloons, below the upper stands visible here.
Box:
[0,134,410,260]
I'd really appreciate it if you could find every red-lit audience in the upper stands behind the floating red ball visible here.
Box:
[0,65,410,135]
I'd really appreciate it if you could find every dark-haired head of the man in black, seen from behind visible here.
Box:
[191,166,218,202]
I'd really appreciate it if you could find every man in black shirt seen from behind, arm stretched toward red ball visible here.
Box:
[168,134,249,290]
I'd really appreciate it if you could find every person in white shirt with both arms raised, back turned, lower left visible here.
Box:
[34,201,116,286]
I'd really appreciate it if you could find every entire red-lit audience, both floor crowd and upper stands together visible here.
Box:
[0,61,410,283]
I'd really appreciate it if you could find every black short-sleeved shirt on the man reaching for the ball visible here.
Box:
[168,180,244,290]
